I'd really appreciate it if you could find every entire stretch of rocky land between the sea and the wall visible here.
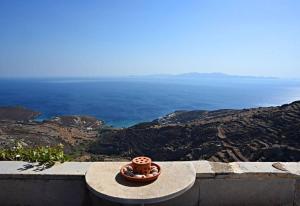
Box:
[0,101,300,162]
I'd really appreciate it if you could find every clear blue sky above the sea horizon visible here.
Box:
[0,0,300,78]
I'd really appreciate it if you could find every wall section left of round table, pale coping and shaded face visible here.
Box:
[0,161,90,206]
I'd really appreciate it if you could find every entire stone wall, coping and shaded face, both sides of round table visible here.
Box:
[0,161,300,206]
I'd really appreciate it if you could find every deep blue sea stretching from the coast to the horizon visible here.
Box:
[0,76,300,127]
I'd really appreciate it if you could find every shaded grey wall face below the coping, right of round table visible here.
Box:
[199,178,295,206]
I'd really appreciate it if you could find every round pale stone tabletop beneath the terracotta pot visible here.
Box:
[85,162,196,205]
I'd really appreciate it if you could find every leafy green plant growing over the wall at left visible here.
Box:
[0,142,68,166]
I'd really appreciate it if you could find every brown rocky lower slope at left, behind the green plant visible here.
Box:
[0,107,103,160]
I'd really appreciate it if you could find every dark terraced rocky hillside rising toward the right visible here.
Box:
[89,101,300,162]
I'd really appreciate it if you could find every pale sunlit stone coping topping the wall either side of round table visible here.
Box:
[0,160,300,179]
